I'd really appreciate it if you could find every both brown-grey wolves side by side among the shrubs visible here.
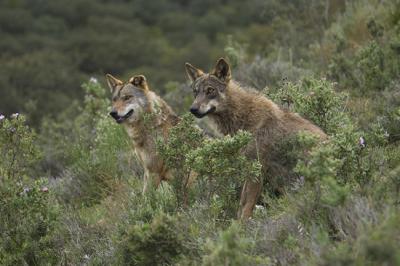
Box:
[106,58,327,219]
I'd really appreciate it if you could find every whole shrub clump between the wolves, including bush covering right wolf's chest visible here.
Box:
[157,114,261,218]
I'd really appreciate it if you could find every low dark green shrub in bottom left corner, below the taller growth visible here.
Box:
[0,180,60,265]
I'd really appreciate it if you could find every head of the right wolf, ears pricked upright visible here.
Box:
[185,58,231,118]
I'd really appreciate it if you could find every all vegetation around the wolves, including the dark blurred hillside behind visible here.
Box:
[0,0,400,265]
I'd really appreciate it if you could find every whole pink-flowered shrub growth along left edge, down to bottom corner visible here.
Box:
[0,114,59,265]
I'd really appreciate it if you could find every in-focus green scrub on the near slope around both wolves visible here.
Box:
[0,1,400,265]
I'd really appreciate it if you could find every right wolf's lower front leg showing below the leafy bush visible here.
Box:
[238,180,262,220]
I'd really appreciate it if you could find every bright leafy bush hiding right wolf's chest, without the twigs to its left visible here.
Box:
[187,131,261,217]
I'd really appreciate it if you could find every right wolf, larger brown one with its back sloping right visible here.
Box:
[185,58,327,219]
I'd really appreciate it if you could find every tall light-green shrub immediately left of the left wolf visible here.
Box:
[42,80,134,205]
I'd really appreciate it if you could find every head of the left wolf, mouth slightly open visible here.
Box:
[106,74,149,124]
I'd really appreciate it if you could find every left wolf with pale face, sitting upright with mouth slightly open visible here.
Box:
[106,74,180,194]
